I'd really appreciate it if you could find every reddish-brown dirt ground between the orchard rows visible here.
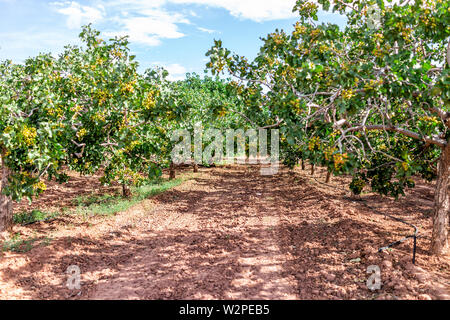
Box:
[0,166,450,300]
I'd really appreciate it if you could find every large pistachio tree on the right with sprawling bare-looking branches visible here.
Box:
[207,0,450,255]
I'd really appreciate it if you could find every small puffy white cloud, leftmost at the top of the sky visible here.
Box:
[51,1,105,29]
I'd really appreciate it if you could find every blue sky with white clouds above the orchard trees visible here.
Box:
[0,0,345,79]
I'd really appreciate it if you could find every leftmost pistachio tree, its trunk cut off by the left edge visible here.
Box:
[0,55,67,231]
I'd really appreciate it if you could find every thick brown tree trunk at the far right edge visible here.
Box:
[431,144,450,255]
